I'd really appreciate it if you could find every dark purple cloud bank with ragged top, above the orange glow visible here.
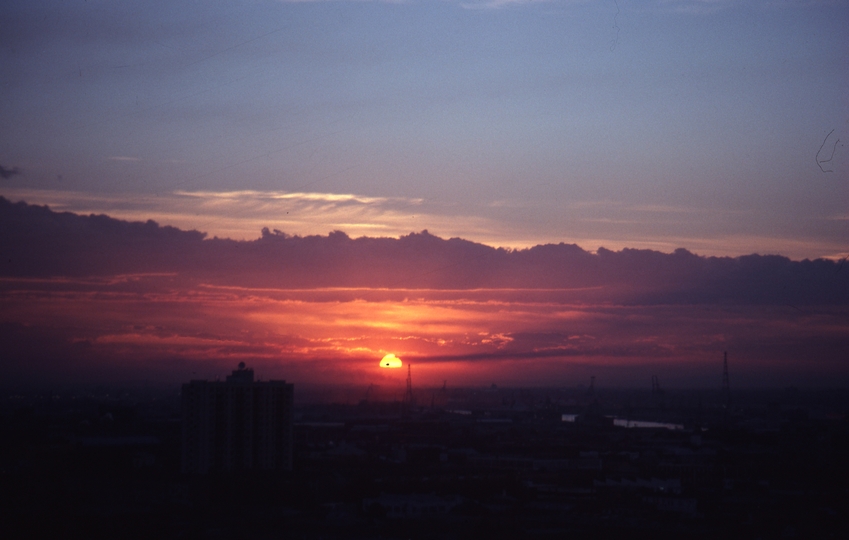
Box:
[0,197,849,309]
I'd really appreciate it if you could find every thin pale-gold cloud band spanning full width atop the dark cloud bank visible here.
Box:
[2,188,846,259]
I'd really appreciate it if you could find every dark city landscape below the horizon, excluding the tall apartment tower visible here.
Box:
[0,385,849,539]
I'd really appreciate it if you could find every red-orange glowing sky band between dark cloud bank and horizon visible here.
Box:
[0,276,849,386]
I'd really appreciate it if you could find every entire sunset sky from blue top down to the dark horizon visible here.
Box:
[0,0,849,386]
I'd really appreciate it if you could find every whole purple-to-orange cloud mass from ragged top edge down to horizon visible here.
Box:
[0,198,849,385]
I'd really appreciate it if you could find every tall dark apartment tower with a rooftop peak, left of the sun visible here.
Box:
[182,362,294,474]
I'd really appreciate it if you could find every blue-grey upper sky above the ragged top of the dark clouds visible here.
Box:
[0,0,849,259]
